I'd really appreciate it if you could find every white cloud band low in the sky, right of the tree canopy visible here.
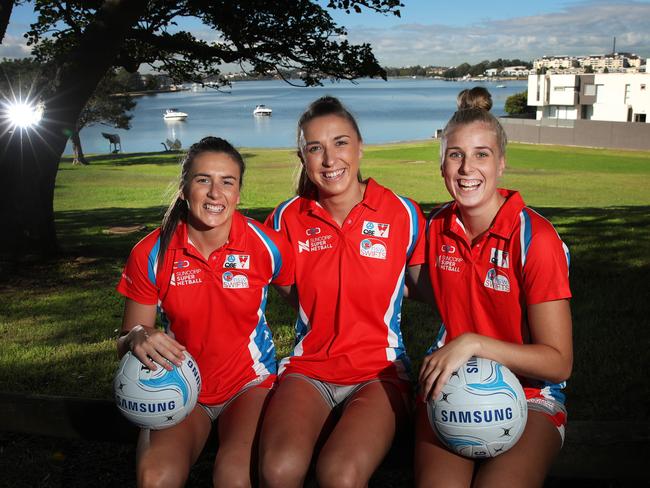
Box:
[340,2,650,66]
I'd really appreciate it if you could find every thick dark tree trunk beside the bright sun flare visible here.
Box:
[0,0,147,259]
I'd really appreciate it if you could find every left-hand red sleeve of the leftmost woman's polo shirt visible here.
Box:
[116,236,158,305]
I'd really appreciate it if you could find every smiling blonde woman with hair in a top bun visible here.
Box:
[415,88,573,487]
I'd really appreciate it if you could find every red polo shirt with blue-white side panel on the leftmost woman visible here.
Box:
[117,212,294,405]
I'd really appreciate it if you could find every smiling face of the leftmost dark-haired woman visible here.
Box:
[182,151,241,231]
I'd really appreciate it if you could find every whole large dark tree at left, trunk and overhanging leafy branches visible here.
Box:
[0,0,402,255]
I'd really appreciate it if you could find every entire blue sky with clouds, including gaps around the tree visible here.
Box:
[0,0,650,67]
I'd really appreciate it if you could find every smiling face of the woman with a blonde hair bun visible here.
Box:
[441,122,505,214]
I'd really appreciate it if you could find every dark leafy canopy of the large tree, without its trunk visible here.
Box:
[27,0,401,85]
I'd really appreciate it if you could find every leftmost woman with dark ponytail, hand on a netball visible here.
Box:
[117,137,294,486]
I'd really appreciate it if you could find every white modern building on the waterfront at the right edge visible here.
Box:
[528,72,650,123]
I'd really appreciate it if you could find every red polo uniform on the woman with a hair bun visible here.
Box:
[427,189,571,403]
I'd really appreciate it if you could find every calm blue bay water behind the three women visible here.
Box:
[66,79,526,154]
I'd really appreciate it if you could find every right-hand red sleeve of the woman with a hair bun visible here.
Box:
[522,222,571,305]
